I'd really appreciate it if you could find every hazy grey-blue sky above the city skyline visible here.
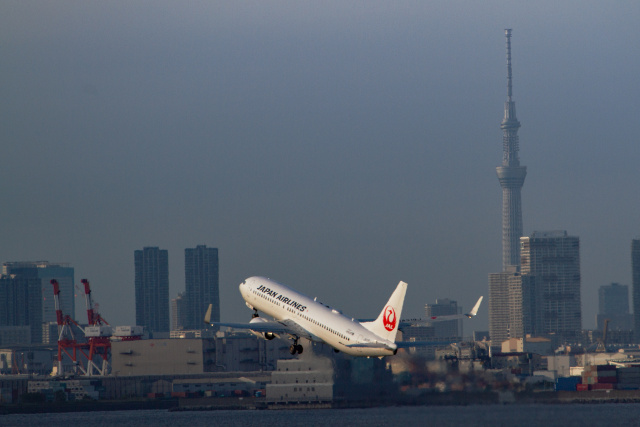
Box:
[0,0,640,332]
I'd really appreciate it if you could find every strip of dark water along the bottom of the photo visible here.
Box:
[0,403,640,427]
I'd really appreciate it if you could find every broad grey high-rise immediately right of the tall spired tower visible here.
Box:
[520,231,582,341]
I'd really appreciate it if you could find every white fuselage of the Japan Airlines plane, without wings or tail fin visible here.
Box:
[240,277,395,356]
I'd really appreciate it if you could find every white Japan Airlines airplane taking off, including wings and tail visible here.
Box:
[204,277,482,357]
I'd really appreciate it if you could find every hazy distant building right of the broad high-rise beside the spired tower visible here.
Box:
[596,283,633,331]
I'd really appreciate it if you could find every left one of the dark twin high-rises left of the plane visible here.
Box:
[134,247,170,333]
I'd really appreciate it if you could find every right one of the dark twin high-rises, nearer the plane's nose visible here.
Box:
[184,245,220,329]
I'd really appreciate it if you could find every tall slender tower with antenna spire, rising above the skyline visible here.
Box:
[496,29,527,271]
